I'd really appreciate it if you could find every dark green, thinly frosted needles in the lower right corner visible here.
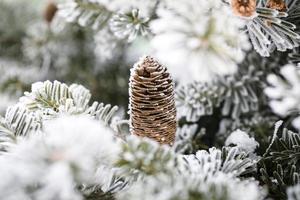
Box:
[258,124,300,199]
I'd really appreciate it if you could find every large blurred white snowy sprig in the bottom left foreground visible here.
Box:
[0,116,120,199]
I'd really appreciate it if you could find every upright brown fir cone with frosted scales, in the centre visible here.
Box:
[129,56,176,145]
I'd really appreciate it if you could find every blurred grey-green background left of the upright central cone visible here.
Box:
[0,0,152,114]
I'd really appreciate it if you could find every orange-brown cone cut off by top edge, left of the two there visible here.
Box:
[231,0,256,17]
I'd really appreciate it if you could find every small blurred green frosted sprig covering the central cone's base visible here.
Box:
[116,136,176,177]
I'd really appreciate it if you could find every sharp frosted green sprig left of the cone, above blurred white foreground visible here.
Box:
[20,81,118,125]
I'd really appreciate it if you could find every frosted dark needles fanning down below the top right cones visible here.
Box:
[246,1,300,57]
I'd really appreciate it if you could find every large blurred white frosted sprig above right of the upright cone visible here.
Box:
[150,0,250,83]
